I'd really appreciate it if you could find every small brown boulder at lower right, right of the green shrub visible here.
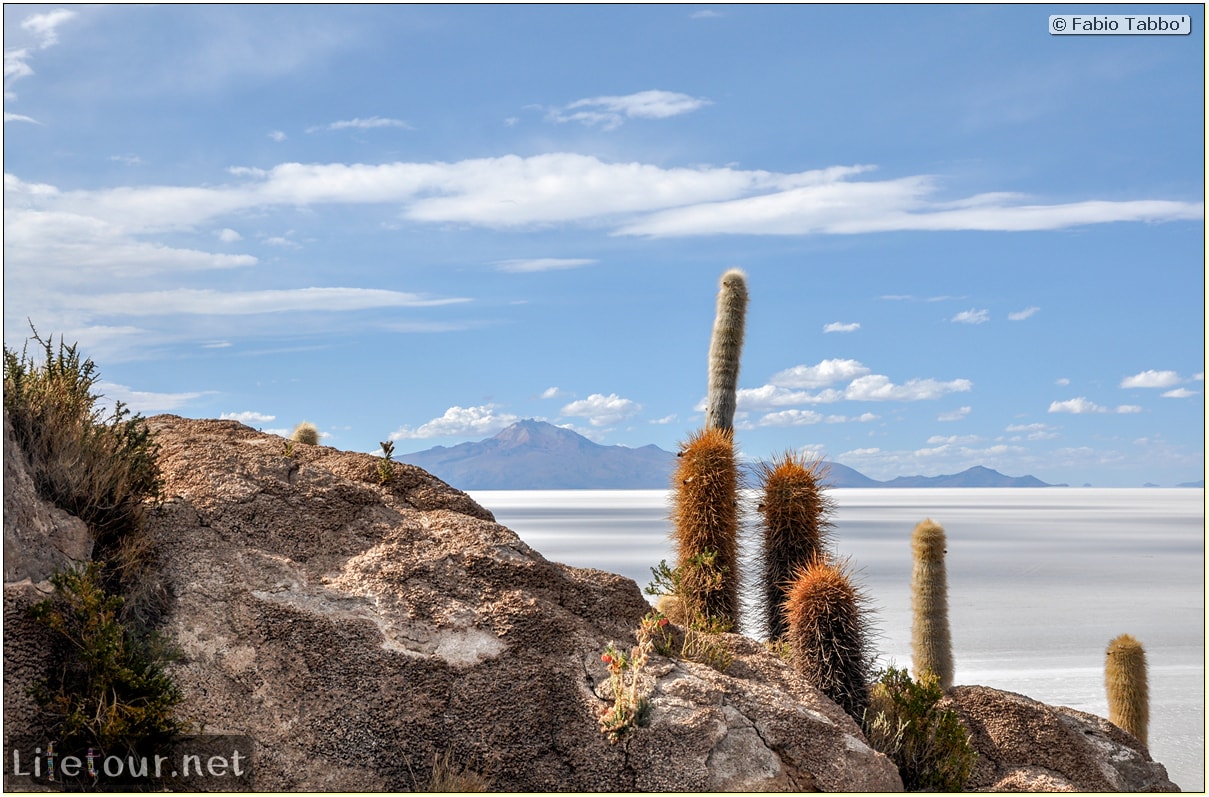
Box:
[944,686,1179,792]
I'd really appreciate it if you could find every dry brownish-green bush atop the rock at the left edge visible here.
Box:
[4,329,160,556]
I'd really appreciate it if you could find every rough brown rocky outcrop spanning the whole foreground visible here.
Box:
[4,416,1170,791]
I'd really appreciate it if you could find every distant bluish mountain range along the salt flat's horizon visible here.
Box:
[395,420,1052,490]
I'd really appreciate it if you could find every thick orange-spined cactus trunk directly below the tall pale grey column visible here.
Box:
[672,428,741,625]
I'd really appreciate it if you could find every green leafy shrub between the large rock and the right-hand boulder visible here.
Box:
[864,666,978,791]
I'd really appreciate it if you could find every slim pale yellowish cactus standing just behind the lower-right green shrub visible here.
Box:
[910,520,953,691]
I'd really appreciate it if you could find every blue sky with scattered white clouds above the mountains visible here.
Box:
[4,5,1205,486]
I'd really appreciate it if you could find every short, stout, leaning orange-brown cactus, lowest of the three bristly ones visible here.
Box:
[785,556,873,722]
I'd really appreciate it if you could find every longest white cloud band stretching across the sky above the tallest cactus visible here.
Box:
[6,152,1204,243]
